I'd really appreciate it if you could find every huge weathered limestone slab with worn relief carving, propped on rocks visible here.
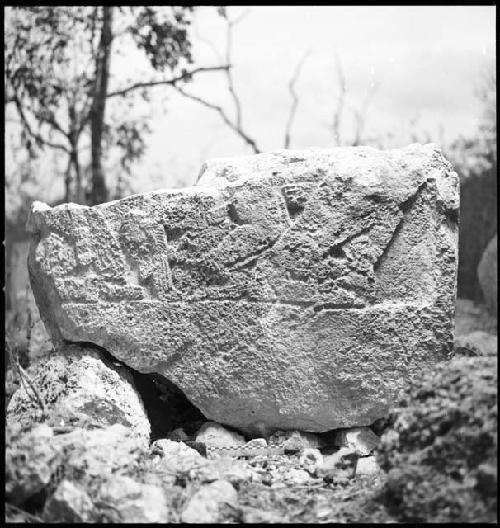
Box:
[29,145,459,434]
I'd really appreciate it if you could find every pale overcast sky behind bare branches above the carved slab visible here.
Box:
[4,6,496,204]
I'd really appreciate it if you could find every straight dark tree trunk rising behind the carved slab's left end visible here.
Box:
[90,6,113,205]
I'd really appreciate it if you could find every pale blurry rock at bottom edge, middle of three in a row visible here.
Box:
[99,475,168,523]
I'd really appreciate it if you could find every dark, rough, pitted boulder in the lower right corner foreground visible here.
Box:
[377,356,498,523]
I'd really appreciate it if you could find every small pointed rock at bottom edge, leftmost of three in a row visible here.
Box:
[43,479,93,523]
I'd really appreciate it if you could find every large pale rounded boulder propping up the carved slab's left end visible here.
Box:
[7,346,151,445]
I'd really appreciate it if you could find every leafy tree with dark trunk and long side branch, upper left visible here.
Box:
[4,6,229,204]
